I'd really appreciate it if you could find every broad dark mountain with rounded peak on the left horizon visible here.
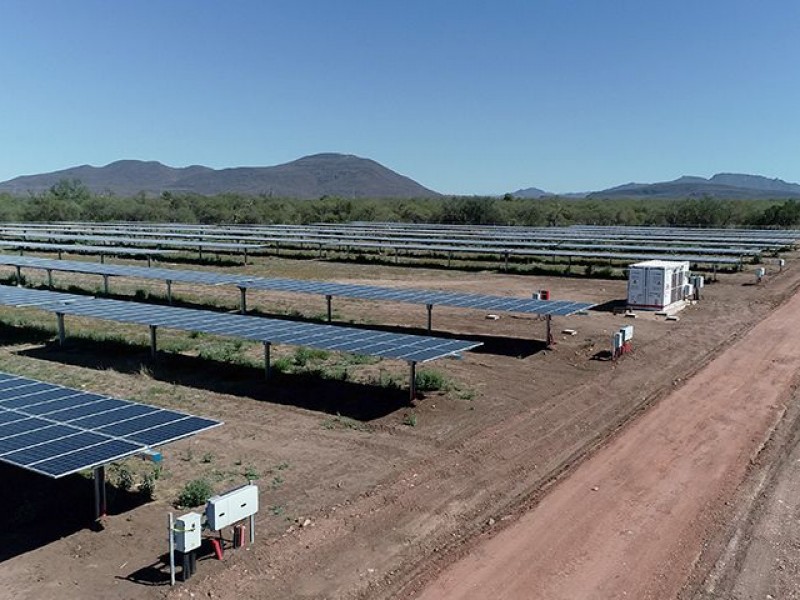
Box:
[0,153,439,198]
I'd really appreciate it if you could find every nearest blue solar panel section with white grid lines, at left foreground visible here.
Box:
[0,372,221,478]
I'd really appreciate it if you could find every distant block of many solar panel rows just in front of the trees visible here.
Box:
[0,223,800,266]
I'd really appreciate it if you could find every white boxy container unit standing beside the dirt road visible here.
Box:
[628,260,689,310]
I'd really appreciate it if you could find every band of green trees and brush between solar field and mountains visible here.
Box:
[0,180,800,228]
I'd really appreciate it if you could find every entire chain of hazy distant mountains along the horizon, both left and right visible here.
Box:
[0,153,800,199]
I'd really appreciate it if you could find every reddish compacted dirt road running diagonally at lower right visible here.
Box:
[418,288,800,600]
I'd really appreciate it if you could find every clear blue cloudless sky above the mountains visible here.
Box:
[0,0,800,194]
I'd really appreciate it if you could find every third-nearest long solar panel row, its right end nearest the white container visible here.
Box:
[0,255,593,316]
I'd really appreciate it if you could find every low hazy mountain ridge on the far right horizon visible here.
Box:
[588,173,800,199]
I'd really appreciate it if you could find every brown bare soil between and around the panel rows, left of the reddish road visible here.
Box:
[0,254,800,599]
